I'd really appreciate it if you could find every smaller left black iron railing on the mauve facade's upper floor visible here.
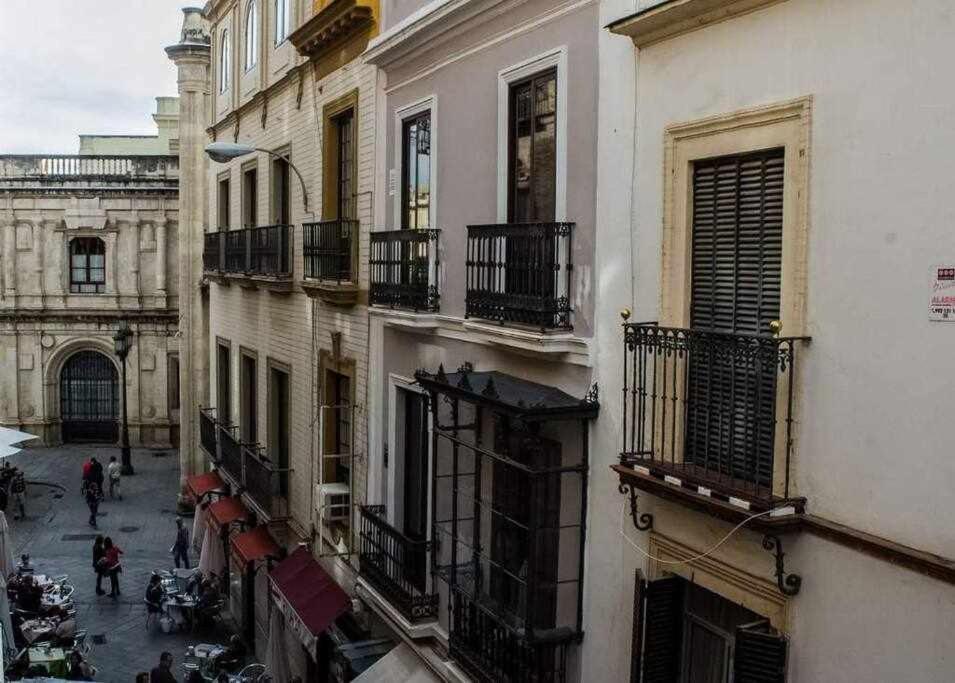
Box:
[368,229,441,311]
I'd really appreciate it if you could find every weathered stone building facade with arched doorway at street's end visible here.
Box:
[0,155,179,447]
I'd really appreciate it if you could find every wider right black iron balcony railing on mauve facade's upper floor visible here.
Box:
[465,223,574,330]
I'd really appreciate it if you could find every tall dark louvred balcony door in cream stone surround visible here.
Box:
[685,149,784,486]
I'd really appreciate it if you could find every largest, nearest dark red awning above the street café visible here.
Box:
[269,548,351,653]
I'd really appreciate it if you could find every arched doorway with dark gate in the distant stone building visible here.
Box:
[60,351,119,443]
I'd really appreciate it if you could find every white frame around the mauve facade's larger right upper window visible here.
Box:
[497,45,567,223]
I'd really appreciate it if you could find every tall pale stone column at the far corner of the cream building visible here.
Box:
[166,12,211,477]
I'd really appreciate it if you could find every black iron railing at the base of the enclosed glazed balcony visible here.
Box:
[448,589,576,683]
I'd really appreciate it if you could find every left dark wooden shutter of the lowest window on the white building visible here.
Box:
[630,572,683,683]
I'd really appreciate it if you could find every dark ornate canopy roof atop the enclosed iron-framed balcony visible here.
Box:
[415,365,600,421]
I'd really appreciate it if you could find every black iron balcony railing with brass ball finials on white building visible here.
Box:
[621,323,809,504]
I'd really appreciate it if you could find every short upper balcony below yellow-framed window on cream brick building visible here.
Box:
[302,220,359,306]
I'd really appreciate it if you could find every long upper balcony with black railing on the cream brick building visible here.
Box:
[202,225,292,291]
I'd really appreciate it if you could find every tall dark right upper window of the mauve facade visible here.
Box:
[507,69,557,223]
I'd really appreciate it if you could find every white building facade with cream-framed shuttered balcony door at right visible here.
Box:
[583,0,955,683]
